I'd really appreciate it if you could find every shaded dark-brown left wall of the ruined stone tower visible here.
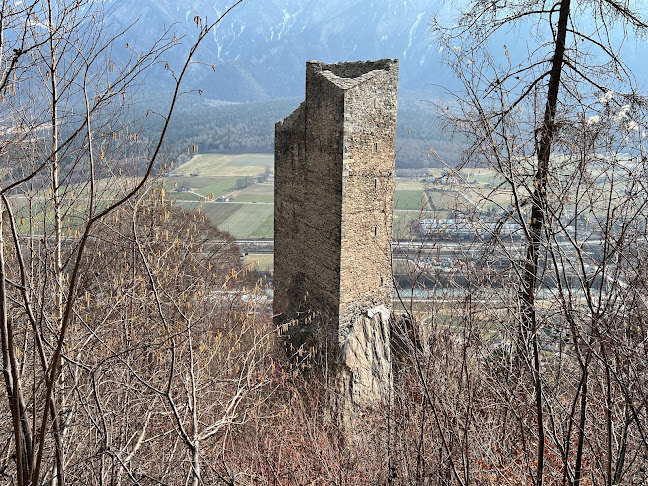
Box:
[274,63,344,340]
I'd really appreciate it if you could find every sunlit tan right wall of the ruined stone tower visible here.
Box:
[340,61,398,339]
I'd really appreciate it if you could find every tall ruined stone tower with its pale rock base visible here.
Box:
[274,59,398,408]
